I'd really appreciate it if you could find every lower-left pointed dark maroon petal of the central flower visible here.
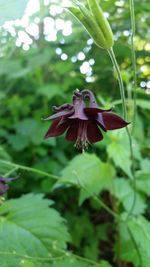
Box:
[44,118,69,138]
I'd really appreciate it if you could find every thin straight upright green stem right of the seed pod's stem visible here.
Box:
[129,0,137,129]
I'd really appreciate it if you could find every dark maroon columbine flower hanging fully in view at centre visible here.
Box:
[45,89,128,150]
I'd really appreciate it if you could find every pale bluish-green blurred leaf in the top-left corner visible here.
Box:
[0,0,28,25]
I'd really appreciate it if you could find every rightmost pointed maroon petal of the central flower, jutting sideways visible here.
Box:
[102,112,129,130]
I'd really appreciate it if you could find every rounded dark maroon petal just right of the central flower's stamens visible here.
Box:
[87,122,103,143]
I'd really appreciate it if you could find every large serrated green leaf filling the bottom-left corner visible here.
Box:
[0,194,69,267]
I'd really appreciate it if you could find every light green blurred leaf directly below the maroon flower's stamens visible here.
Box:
[56,153,115,204]
